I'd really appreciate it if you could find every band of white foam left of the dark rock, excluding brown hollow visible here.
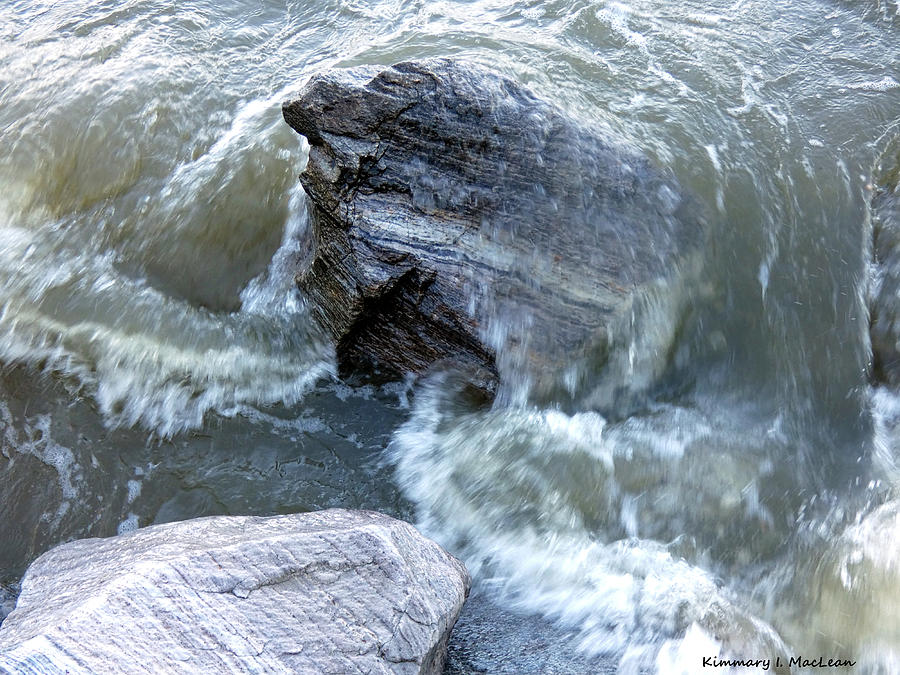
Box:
[0,195,334,436]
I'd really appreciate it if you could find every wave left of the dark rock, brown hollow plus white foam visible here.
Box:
[0,93,334,436]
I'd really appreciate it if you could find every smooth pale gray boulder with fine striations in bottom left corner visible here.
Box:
[0,510,470,675]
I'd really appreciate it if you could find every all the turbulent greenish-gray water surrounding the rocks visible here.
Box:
[0,0,900,673]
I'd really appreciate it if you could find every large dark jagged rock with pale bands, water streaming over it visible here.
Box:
[283,59,700,398]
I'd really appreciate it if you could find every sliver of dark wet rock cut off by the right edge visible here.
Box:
[870,140,900,387]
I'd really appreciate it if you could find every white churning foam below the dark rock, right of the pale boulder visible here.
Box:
[391,376,786,672]
